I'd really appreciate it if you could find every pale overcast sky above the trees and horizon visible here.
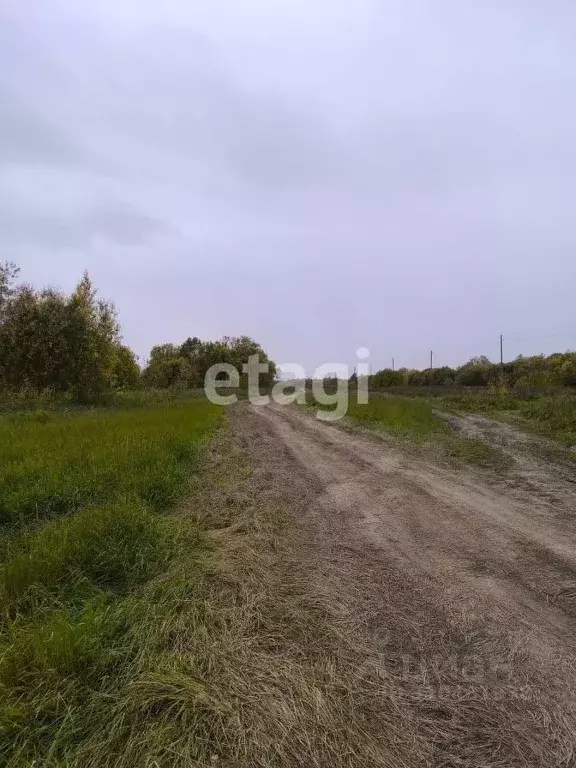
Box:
[0,0,576,373]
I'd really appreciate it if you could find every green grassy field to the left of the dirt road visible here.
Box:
[0,397,223,768]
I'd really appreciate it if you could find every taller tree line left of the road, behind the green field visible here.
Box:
[0,262,276,401]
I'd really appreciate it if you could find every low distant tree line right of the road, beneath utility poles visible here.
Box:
[370,352,576,389]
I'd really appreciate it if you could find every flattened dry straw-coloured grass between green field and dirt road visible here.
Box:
[73,432,399,768]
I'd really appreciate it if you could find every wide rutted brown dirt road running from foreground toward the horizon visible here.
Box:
[233,405,576,768]
